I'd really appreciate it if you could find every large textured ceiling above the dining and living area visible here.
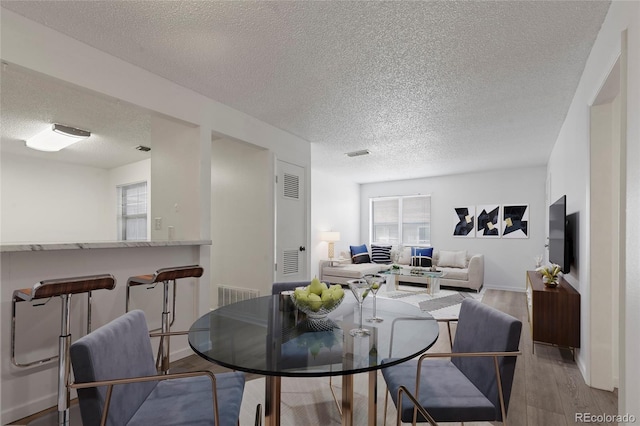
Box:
[2,0,609,182]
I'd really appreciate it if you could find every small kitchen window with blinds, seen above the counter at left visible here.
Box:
[118,182,147,240]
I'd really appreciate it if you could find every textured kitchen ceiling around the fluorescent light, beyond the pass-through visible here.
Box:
[0,65,151,169]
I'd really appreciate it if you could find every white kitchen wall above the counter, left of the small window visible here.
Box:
[0,154,116,244]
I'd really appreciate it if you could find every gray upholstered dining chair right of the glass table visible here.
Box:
[382,298,522,424]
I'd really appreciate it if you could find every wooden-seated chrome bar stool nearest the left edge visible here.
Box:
[11,274,116,425]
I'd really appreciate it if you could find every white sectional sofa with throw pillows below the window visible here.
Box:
[320,247,484,291]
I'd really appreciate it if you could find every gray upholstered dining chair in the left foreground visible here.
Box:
[69,310,261,426]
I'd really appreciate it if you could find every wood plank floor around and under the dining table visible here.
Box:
[172,290,618,426]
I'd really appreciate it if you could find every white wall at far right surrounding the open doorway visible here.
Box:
[547,1,640,419]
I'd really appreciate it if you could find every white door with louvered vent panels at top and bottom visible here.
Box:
[275,160,308,282]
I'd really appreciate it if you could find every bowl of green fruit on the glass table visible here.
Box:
[291,278,344,319]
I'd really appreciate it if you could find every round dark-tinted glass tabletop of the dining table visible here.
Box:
[189,292,439,377]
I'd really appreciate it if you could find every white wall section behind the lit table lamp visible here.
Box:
[309,168,360,278]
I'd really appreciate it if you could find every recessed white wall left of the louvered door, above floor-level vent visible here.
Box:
[211,138,274,307]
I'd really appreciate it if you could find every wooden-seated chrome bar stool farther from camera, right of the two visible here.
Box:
[126,265,204,374]
